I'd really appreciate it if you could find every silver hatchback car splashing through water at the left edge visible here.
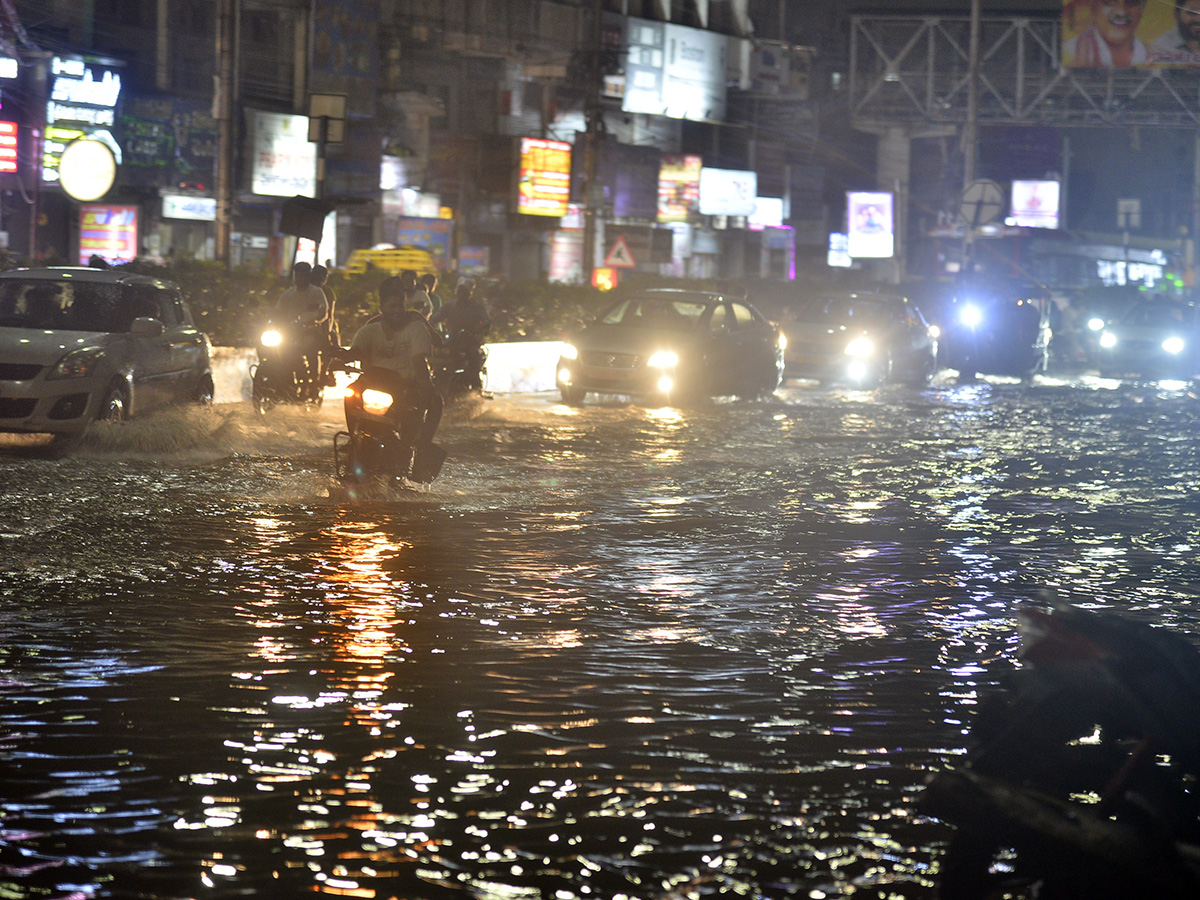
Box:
[0,268,212,438]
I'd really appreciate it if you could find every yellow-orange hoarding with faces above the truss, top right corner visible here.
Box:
[1062,0,1200,68]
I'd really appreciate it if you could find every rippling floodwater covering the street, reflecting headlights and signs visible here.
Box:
[0,378,1200,900]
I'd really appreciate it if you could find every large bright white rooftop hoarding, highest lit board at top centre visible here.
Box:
[620,18,730,122]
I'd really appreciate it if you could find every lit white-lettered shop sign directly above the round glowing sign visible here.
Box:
[42,56,121,181]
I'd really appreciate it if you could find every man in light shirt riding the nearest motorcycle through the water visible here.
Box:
[343,278,443,478]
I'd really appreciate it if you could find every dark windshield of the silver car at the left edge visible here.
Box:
[0,278,127,331]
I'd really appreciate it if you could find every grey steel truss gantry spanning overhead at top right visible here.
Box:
[850,16,1200,128]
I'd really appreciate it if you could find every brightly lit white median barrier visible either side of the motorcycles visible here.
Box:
[212,341,562,403]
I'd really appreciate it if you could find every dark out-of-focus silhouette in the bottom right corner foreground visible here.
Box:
[924,605,1200,900]
